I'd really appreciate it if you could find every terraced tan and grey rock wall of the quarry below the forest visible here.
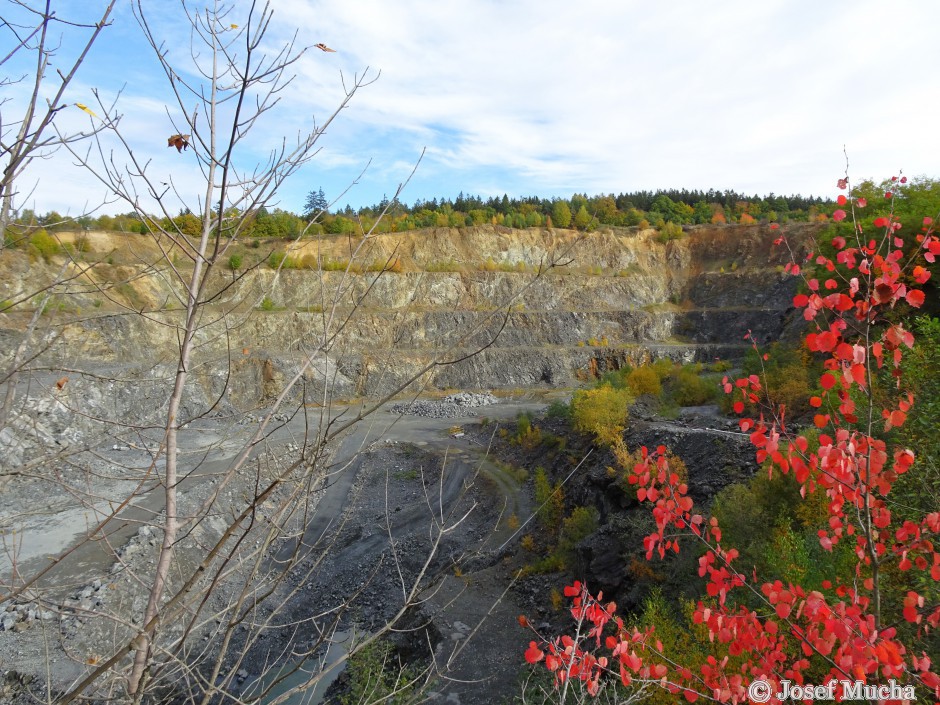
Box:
[0,225,815,404]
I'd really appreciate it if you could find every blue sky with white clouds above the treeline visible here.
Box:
[2,0,940,215]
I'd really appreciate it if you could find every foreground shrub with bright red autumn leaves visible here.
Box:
[525,173,940,703]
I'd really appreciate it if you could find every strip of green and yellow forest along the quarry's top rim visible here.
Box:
[7,177,940,244]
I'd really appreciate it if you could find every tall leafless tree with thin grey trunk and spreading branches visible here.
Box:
[1,2,580,704]
